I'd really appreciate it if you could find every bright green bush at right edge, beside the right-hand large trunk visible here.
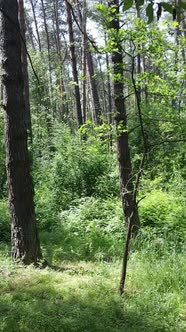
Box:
[139,190,186,250]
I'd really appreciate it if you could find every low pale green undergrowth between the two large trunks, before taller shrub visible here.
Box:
[41,197,124,261]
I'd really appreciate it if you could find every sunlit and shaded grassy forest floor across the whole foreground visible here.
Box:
[0,246,186,332]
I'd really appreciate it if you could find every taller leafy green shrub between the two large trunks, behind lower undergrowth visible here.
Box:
[34,125,119,227]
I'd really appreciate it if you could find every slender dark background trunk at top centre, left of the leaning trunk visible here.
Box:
[65,0,83,127]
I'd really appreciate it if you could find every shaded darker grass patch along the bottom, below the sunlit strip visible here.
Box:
[0,275,173,332]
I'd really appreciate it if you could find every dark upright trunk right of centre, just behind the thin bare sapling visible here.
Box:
[109,0,140,234]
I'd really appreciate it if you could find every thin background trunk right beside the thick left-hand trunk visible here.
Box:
[19,0,32,142]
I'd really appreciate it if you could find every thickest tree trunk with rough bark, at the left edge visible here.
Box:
[0,0,41,264]
